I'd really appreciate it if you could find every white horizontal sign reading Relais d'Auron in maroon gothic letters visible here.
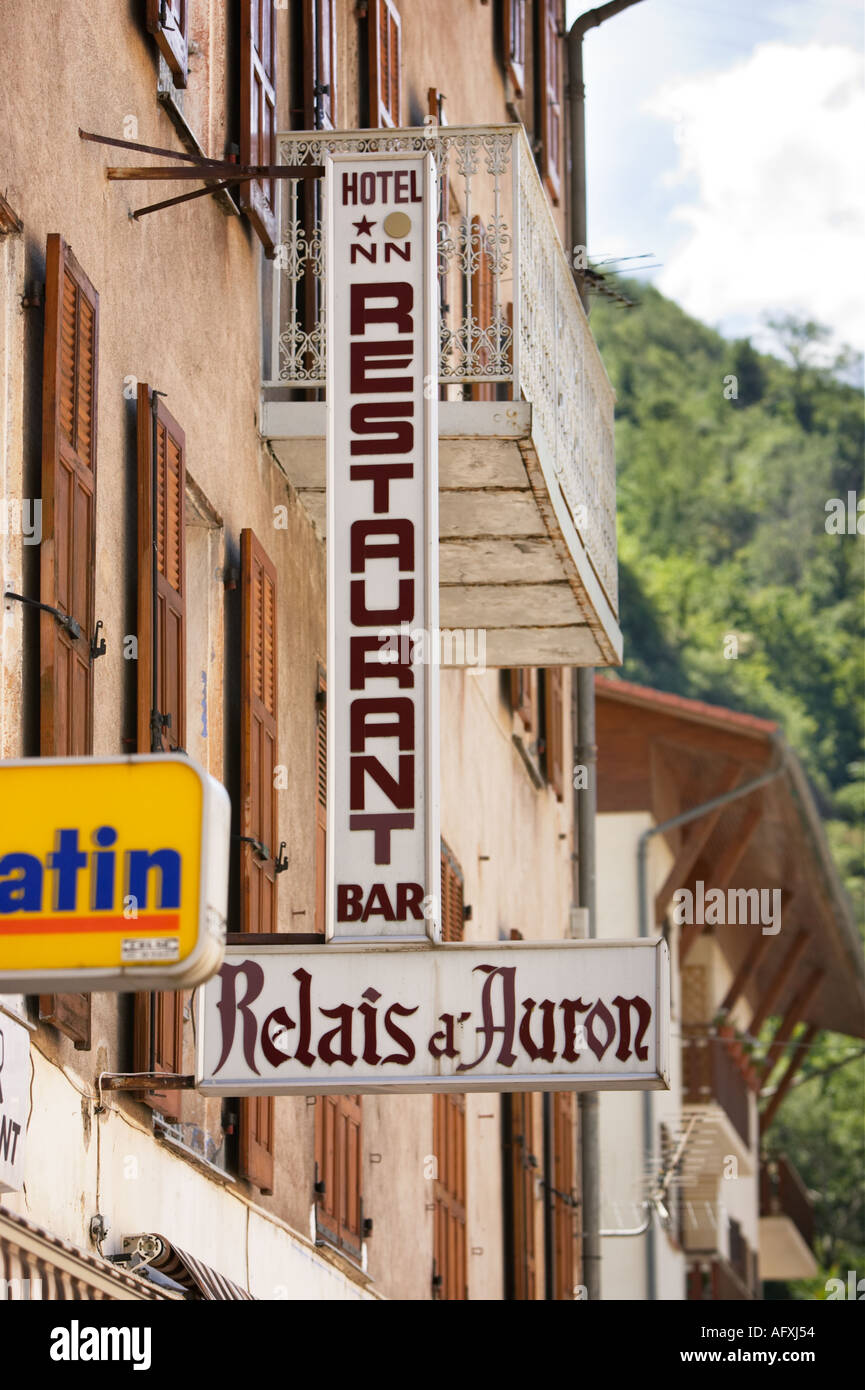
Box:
[197,940,670,1095]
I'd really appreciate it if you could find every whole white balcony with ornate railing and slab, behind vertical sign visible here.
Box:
[260,125,622,666]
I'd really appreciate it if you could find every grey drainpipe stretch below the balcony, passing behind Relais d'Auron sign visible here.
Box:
[572,667,601,1301]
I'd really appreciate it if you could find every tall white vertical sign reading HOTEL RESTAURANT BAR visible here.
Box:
[327,153,441,941]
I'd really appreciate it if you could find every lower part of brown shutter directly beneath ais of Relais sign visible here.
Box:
[316,1095,363,1259]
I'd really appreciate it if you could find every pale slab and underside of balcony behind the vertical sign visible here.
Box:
[261,399,622,666]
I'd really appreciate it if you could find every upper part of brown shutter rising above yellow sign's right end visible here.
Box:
[138,382,186,753]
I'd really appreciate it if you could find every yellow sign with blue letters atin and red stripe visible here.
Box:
[0,753,231,994]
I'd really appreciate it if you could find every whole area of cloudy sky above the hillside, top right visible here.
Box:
[567,0,865,364]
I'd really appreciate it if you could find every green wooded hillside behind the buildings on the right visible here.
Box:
[591,281,865,1297]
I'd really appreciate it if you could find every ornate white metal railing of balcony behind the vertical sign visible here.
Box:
[263,125,617,612]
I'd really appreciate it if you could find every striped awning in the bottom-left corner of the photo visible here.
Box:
[0,1207,176,1301]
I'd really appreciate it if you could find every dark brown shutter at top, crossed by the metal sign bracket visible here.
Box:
[241,0,278,256]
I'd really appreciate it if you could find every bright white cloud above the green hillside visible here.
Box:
[647,43,865,350]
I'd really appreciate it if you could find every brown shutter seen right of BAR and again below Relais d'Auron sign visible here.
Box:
[433,844,469,1300]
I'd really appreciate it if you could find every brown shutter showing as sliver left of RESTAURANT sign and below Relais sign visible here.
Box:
[314,670,363,1259]
